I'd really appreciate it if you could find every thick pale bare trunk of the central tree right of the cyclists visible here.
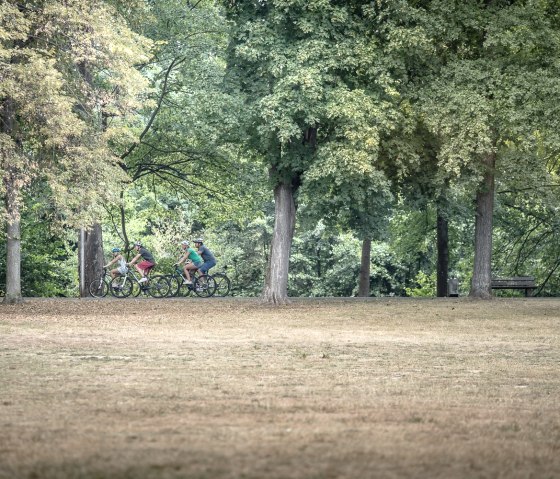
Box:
[262,183,296,304]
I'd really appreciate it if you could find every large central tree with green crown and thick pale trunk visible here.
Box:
[226,0,420,303]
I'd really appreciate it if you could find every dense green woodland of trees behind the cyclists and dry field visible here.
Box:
[0,0,560,302]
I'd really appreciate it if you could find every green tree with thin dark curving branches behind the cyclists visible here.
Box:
[105,0,251,256]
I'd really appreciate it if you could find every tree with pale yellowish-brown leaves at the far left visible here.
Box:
[0,0,149,302]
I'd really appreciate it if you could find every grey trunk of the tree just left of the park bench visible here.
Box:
[469,153,496,299]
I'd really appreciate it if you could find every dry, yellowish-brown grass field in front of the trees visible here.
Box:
[0,298,560,479]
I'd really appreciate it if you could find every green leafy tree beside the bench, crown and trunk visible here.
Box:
[416,1,560,298]
